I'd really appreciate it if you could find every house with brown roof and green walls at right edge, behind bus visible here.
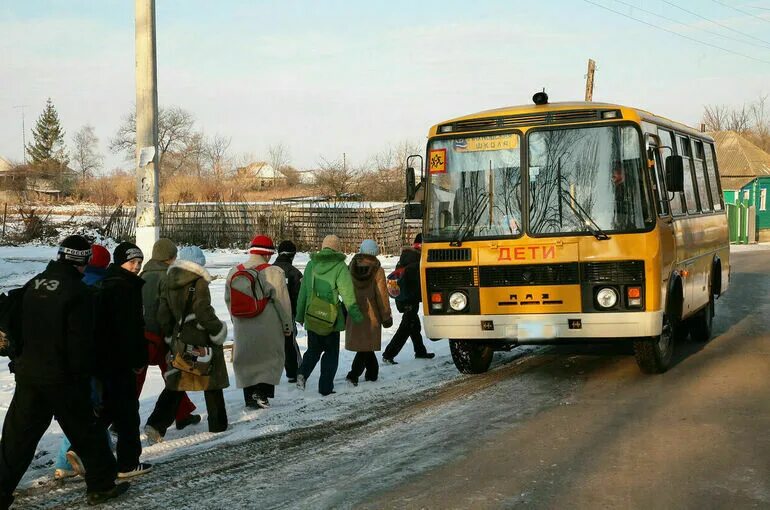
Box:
[710,131,770,241]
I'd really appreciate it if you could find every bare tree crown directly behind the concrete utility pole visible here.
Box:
[109,106,195,171]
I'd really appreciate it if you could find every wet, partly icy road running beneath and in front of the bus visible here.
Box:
[6,249,770,509]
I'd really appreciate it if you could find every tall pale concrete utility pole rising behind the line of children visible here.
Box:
[135,0,160,259]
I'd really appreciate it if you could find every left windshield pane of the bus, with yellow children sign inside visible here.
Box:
[425,133,522,241]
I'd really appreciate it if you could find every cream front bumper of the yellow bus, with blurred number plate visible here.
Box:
[424,311,663,344]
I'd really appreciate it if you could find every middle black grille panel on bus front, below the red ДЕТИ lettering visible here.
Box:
[479,262,579,287]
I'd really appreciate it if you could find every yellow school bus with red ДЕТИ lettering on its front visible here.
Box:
[407,93,730,373]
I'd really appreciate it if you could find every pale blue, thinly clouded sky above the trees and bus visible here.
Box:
[0,0,770,170]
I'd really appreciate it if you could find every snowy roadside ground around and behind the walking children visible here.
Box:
[0,246,458,487]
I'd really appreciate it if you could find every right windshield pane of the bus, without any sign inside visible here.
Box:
[527,126,652,235]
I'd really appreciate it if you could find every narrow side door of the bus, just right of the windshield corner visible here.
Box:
[647,141,676,309]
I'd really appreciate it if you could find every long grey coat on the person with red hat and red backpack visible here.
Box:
[225,255,294,388]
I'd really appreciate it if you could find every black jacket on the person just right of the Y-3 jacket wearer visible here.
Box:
[97,264,148,375]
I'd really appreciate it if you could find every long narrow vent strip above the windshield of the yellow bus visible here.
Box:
[439,110,620,133]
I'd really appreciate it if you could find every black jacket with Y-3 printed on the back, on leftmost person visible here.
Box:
[14,261,94,385]
